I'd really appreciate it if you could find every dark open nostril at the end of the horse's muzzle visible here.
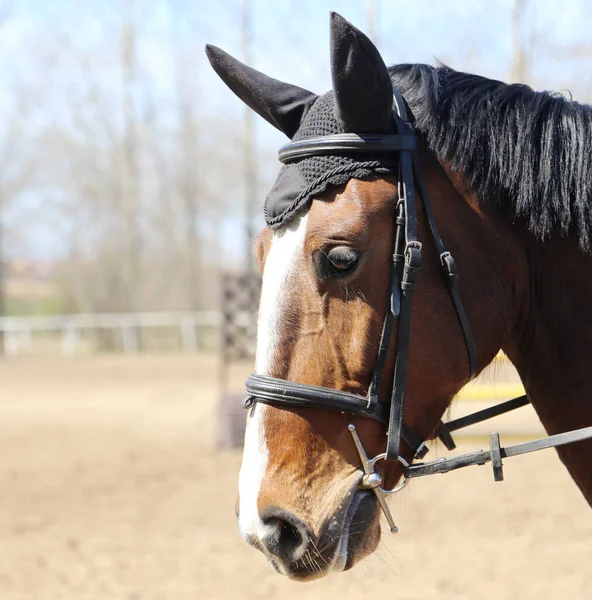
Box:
[261,511,310,564]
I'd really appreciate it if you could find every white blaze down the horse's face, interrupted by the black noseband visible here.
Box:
[238,215,307,539]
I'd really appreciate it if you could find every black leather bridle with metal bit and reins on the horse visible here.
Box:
[244,87,592,532]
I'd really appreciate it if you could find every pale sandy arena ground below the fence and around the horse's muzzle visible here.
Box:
[0,356,592,600]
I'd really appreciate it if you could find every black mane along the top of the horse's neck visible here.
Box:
[389,64,592,250]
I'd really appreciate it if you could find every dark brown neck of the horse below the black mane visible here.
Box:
[504,234,592,505]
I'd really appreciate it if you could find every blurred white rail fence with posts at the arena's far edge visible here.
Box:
[0,311,231,356]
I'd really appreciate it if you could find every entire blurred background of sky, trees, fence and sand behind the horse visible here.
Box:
[0,0,592,600]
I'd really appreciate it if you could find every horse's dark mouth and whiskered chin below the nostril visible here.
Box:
[270,490,380,581]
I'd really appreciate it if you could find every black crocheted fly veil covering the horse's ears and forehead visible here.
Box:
[206,13,397,229]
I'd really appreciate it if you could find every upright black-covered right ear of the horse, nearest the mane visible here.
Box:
[331,12,393,133]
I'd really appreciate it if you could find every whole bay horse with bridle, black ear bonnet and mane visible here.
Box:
[207,13,592,580]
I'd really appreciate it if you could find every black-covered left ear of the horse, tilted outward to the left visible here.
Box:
[206,45,318,138]
